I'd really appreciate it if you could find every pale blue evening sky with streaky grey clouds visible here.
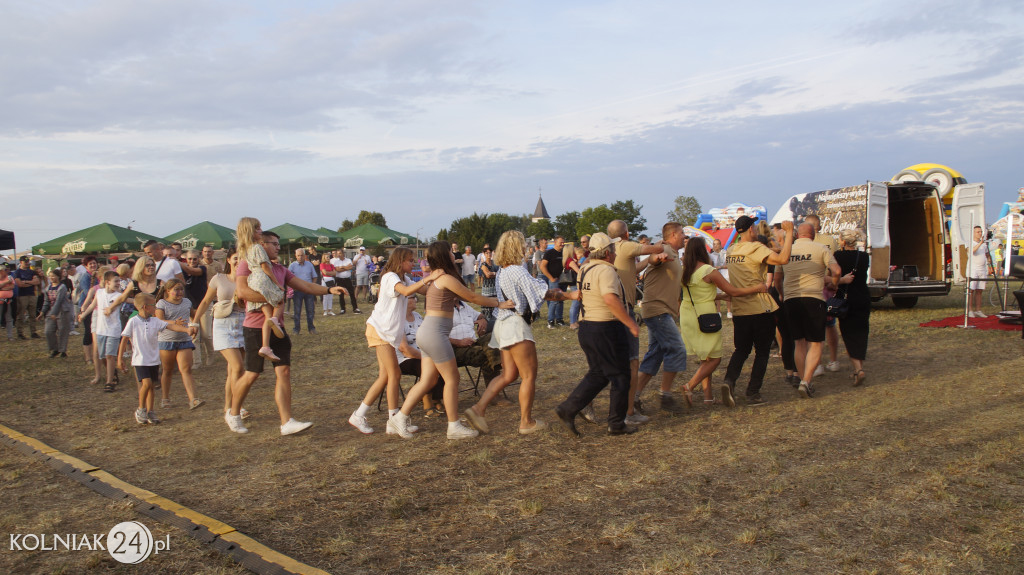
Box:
[0,0,1024,248]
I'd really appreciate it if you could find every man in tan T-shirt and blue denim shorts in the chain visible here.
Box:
[626,217,686,411]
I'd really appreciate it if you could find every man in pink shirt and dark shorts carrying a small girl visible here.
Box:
[224,231,347,435]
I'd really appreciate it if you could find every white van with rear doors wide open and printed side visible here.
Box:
[771,181,985,308]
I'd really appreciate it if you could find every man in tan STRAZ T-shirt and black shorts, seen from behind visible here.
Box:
[782,222,840,398]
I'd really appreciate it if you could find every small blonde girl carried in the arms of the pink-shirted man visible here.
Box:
[236,218,285,361]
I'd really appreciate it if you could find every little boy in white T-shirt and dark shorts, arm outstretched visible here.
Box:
[118,294,196,425]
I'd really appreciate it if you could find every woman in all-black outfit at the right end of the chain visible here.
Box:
[833,229,871,386]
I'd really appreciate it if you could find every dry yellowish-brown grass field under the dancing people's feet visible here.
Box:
[0,290,1024,575]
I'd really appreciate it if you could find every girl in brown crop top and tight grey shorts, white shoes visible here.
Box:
[387,241,515,439]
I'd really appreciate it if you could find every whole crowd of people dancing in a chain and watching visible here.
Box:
[0,216,870,439]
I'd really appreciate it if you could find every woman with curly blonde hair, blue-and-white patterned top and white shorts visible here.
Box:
[466,230,579,435]
